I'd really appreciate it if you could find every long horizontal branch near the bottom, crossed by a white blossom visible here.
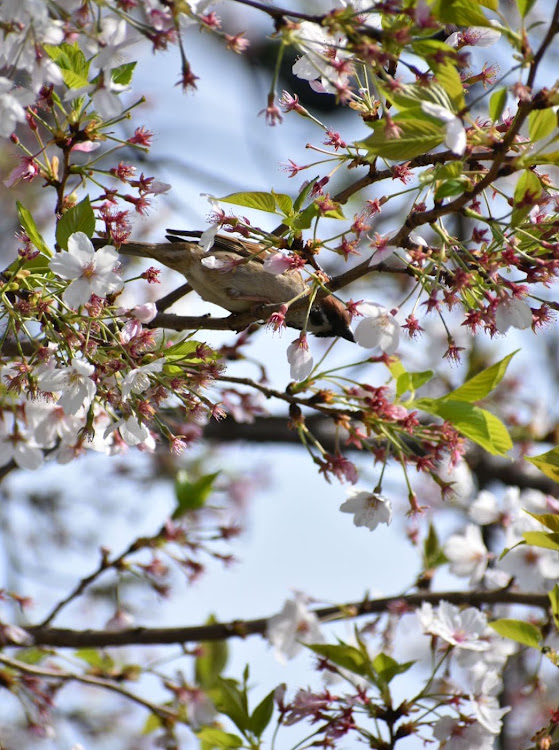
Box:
[20,589,549,648]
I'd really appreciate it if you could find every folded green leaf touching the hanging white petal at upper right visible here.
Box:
[364,115,446,161]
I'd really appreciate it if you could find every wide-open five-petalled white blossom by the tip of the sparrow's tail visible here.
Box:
[49,232,124,308]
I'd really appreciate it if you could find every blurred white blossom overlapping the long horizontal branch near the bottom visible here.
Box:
[266,592,323,661]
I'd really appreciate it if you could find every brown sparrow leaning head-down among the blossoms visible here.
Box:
[115,229,354,341]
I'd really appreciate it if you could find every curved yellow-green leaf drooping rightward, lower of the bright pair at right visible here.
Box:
[416,398,512,456]
